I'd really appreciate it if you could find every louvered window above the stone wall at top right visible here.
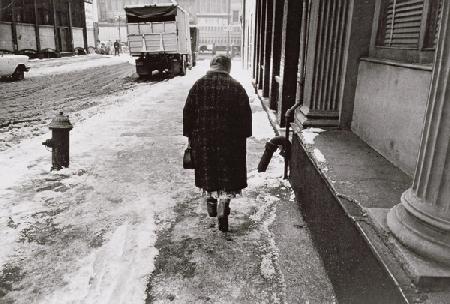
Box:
[371,0,442,63]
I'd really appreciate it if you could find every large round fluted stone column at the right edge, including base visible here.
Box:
[387,1,450,265]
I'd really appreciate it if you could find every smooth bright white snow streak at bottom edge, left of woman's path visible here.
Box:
[42,200,158,304]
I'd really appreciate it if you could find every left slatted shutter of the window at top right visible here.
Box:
[383,0,424,49]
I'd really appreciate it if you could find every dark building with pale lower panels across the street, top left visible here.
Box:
[0,0,87,55]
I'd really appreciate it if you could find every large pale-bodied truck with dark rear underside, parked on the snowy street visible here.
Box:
[125,4,192,76]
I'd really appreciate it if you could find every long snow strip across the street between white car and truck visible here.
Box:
[26,54,134,77]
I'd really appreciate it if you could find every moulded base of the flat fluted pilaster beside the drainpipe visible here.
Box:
[296,106,339,128]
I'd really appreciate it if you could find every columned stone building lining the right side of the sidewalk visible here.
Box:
[243,0,450,303]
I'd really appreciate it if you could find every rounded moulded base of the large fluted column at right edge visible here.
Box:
[387,189,450,265]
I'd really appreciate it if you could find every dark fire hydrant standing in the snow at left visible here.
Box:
[42,112,73,170]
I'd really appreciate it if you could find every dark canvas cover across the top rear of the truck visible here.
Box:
[125,5,177,23]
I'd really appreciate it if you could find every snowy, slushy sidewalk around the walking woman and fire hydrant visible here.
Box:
[0,58,333,304]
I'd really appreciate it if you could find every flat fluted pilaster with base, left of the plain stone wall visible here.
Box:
[297,0,349,127]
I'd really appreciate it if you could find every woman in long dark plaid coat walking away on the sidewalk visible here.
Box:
[183,55,252,232]
